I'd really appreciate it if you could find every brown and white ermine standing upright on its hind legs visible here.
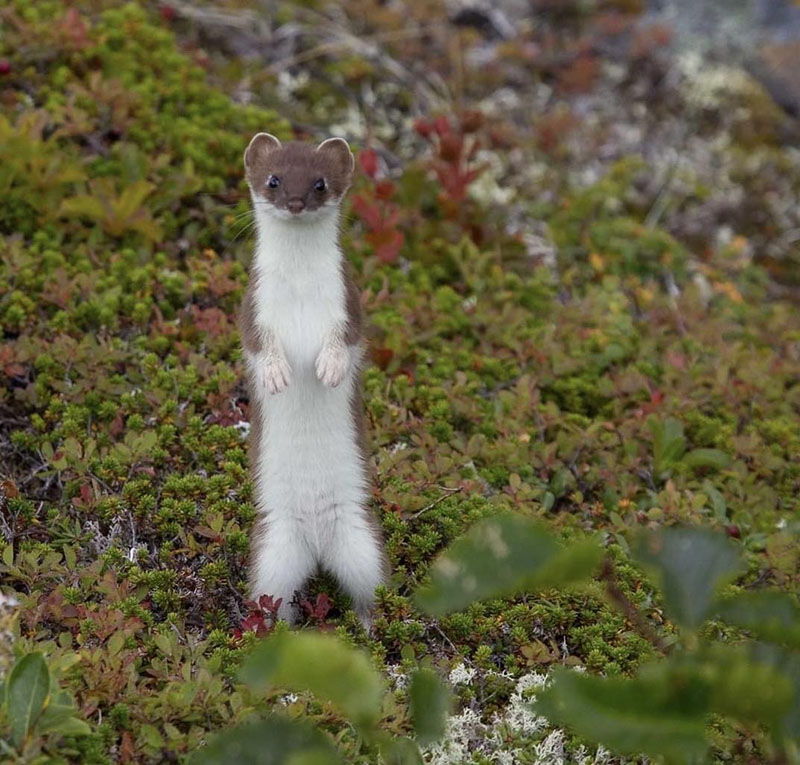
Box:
[240,133,386,628]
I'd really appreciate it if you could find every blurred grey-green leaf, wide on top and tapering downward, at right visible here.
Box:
[631,528,742,629]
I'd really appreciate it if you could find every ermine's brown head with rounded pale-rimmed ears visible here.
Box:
[244,133,355,220]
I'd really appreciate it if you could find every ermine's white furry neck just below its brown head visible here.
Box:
[254,210,342,275]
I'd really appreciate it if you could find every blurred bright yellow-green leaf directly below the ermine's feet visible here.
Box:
[241,632,384,732]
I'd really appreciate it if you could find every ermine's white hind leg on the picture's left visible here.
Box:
[250,517,316,624]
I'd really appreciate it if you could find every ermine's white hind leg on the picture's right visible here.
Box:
[323,506,386,630]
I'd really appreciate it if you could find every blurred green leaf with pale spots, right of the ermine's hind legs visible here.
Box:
[415,514,602,616]
